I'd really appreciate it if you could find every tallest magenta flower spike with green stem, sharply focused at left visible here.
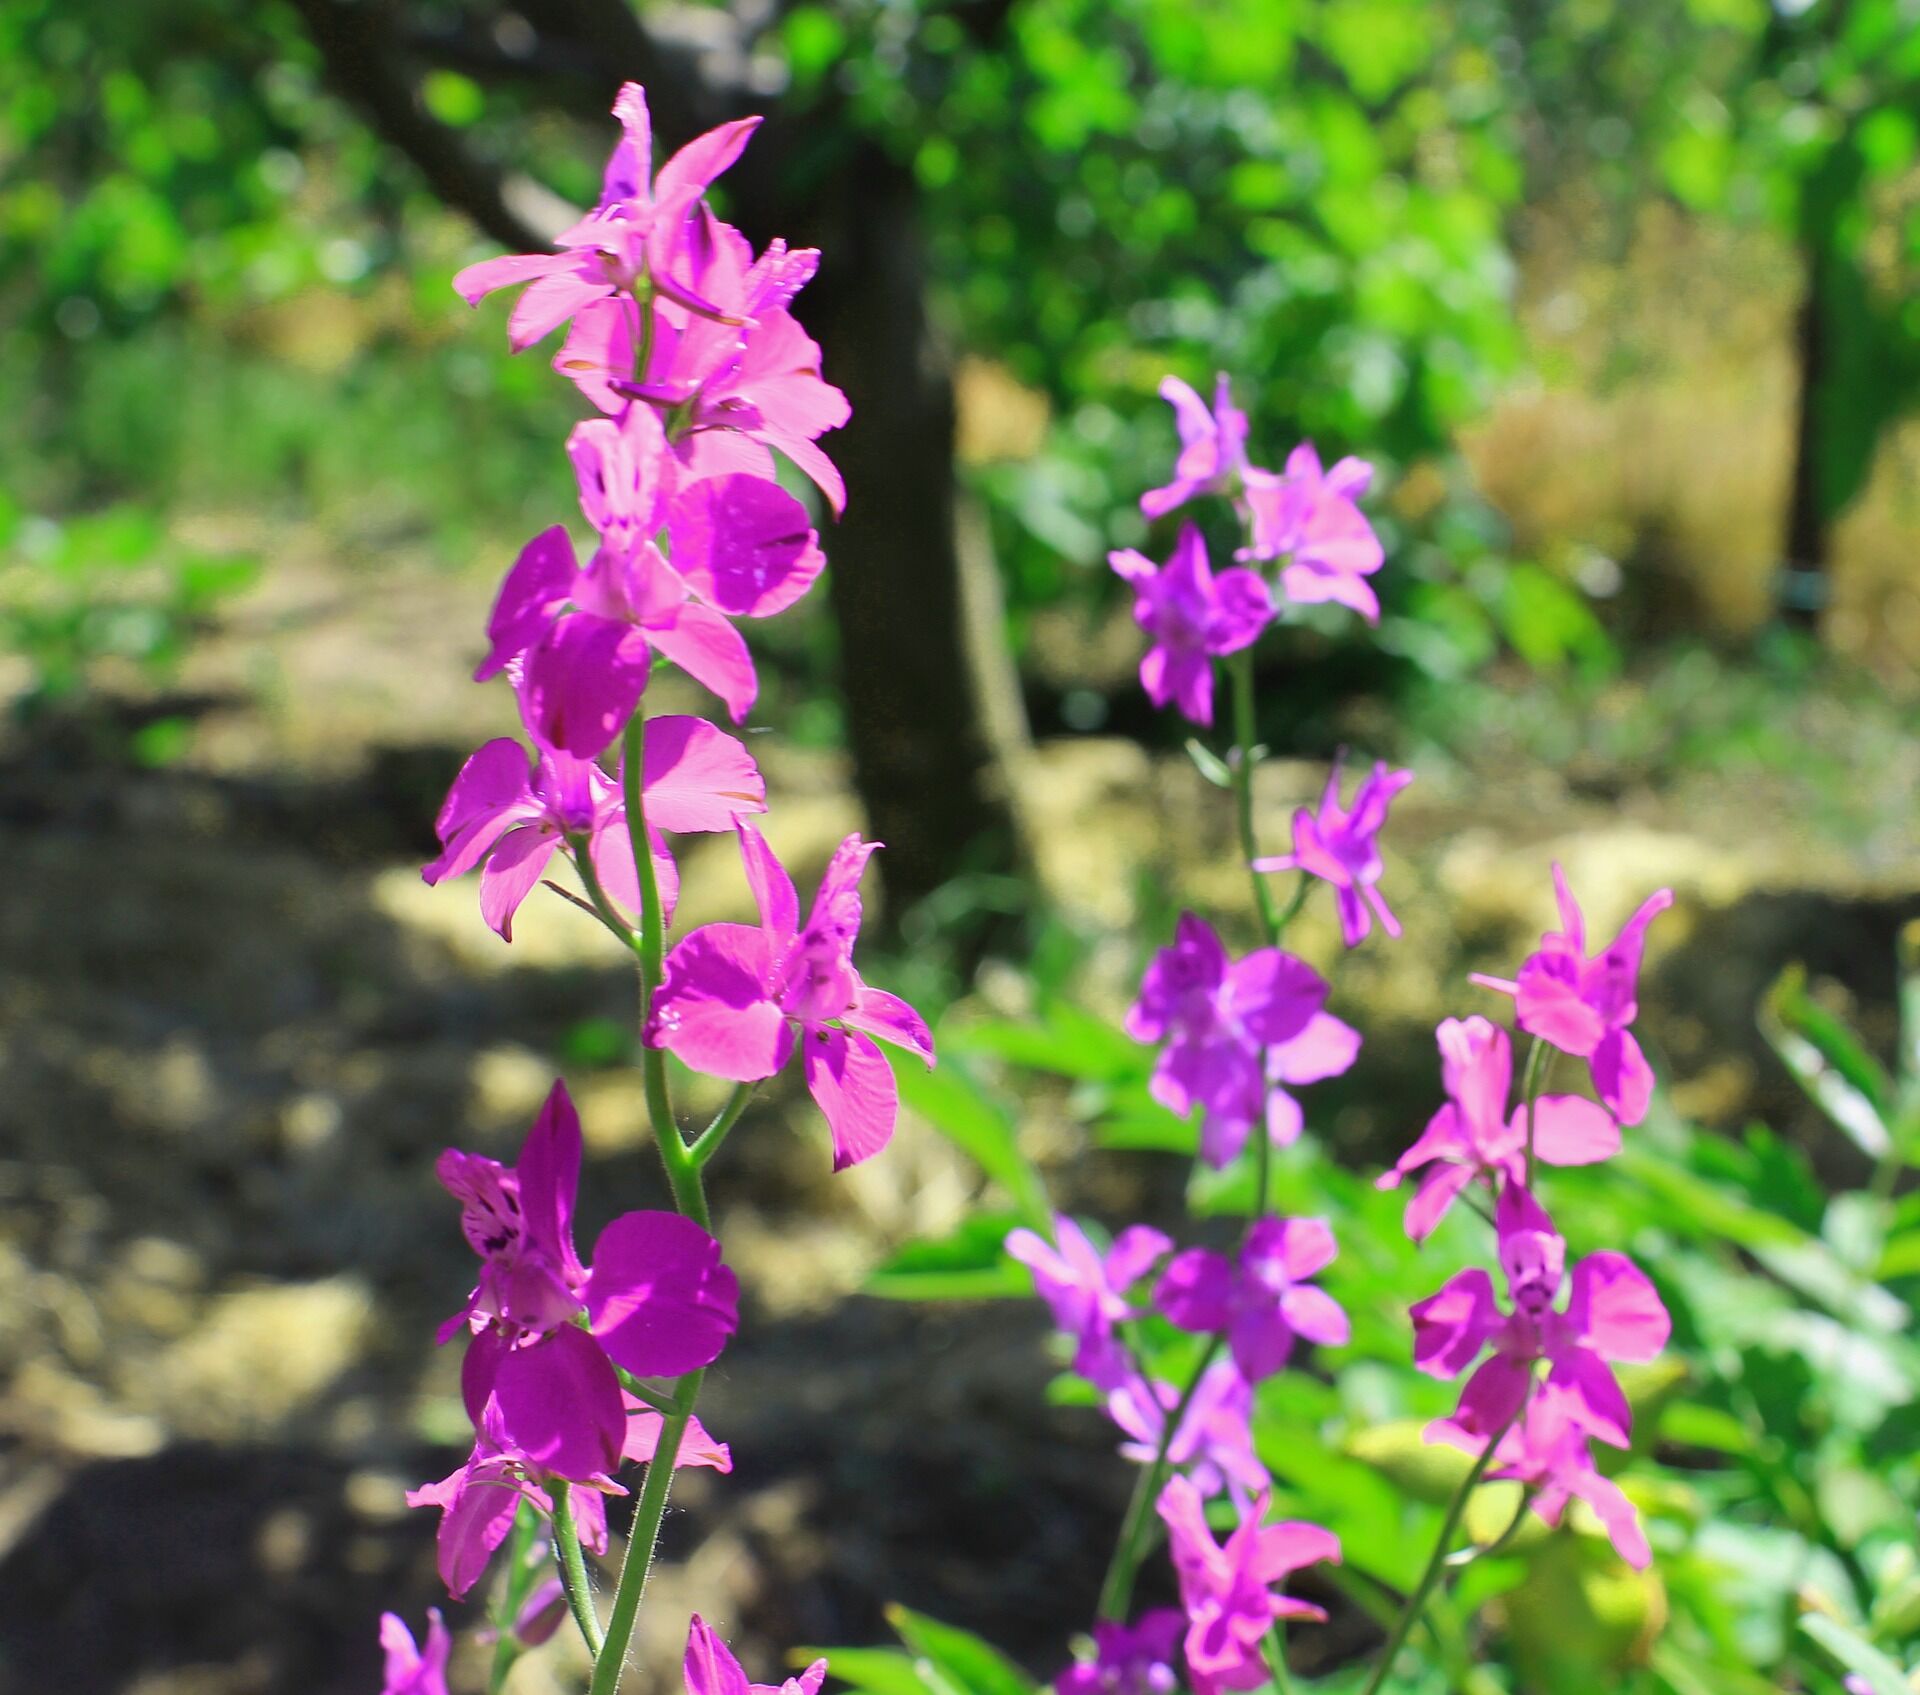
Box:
[380,84,933,1695]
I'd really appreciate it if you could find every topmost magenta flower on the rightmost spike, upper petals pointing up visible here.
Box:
[1473,866,1674,1125]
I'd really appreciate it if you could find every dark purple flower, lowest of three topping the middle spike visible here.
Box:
[1106,524,1273,724]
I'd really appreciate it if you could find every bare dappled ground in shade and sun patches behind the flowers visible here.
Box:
[0,533,1920,1695]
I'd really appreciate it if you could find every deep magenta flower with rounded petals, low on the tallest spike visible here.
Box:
[434,1083,739,1482]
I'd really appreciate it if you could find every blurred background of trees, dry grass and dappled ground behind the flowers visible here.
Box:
[0,0,1920,1695]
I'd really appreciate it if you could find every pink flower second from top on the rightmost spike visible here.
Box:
[1379,1017,1620,1242]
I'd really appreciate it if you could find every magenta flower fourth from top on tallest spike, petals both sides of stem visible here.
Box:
[420,716,766,943]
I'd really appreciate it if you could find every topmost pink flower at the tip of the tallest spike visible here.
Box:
[453,83,760,353]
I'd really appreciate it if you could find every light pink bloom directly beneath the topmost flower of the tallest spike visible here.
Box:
[553,205,849,513]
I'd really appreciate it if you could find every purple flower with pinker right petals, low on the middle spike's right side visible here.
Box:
[1154,1219,1350,1384]
